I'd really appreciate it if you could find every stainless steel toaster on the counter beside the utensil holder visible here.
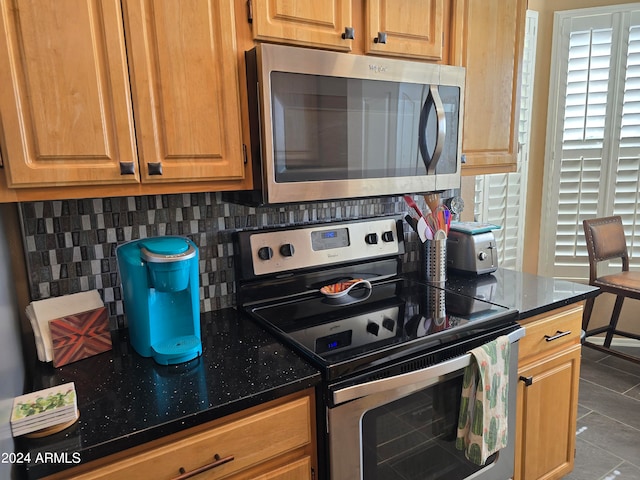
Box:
[447,230,498,275]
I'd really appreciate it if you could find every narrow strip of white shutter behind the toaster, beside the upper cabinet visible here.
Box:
[474,11,538,270]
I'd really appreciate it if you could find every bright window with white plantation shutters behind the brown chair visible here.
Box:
[539,4,640,279]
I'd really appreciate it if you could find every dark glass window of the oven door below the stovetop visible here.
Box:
[362,375,498,480]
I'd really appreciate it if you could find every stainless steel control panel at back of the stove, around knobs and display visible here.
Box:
[250,218,402,275]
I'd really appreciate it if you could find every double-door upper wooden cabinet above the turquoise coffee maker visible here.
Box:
[0,0,244,195]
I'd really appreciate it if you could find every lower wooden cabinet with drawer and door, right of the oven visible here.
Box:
[514,305,583,480]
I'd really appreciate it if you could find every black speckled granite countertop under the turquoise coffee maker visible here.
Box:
[17,309,320,478]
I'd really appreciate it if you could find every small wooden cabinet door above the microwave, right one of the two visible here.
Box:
[365,0,444,60]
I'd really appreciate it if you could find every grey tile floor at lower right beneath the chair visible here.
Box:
[563,347,640,480]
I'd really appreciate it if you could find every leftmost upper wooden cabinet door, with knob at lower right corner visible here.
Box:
[0,0,139,188]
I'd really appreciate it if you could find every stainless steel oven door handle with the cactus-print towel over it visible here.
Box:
[333,328,525,405]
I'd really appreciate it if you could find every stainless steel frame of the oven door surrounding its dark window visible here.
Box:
[327,328,524,480]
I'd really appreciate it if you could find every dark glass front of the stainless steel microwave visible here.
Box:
[271,72,460,183]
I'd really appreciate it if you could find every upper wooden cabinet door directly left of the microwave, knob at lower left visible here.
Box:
[123,0,244,183]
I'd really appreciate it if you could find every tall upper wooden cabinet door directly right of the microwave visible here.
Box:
[452,0,527,175]
